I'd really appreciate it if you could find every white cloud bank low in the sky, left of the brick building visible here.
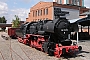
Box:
[0,2,29,23]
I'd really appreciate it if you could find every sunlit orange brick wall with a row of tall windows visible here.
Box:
[26,2,53,22]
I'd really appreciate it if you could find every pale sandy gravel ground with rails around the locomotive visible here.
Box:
[0,32,90,60]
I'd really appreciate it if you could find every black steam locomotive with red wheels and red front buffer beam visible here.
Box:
[16,17,82,58]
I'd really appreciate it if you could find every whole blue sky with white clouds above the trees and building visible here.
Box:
[0,0,90,23]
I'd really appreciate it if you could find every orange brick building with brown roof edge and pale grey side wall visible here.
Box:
[26,1,89,22]
